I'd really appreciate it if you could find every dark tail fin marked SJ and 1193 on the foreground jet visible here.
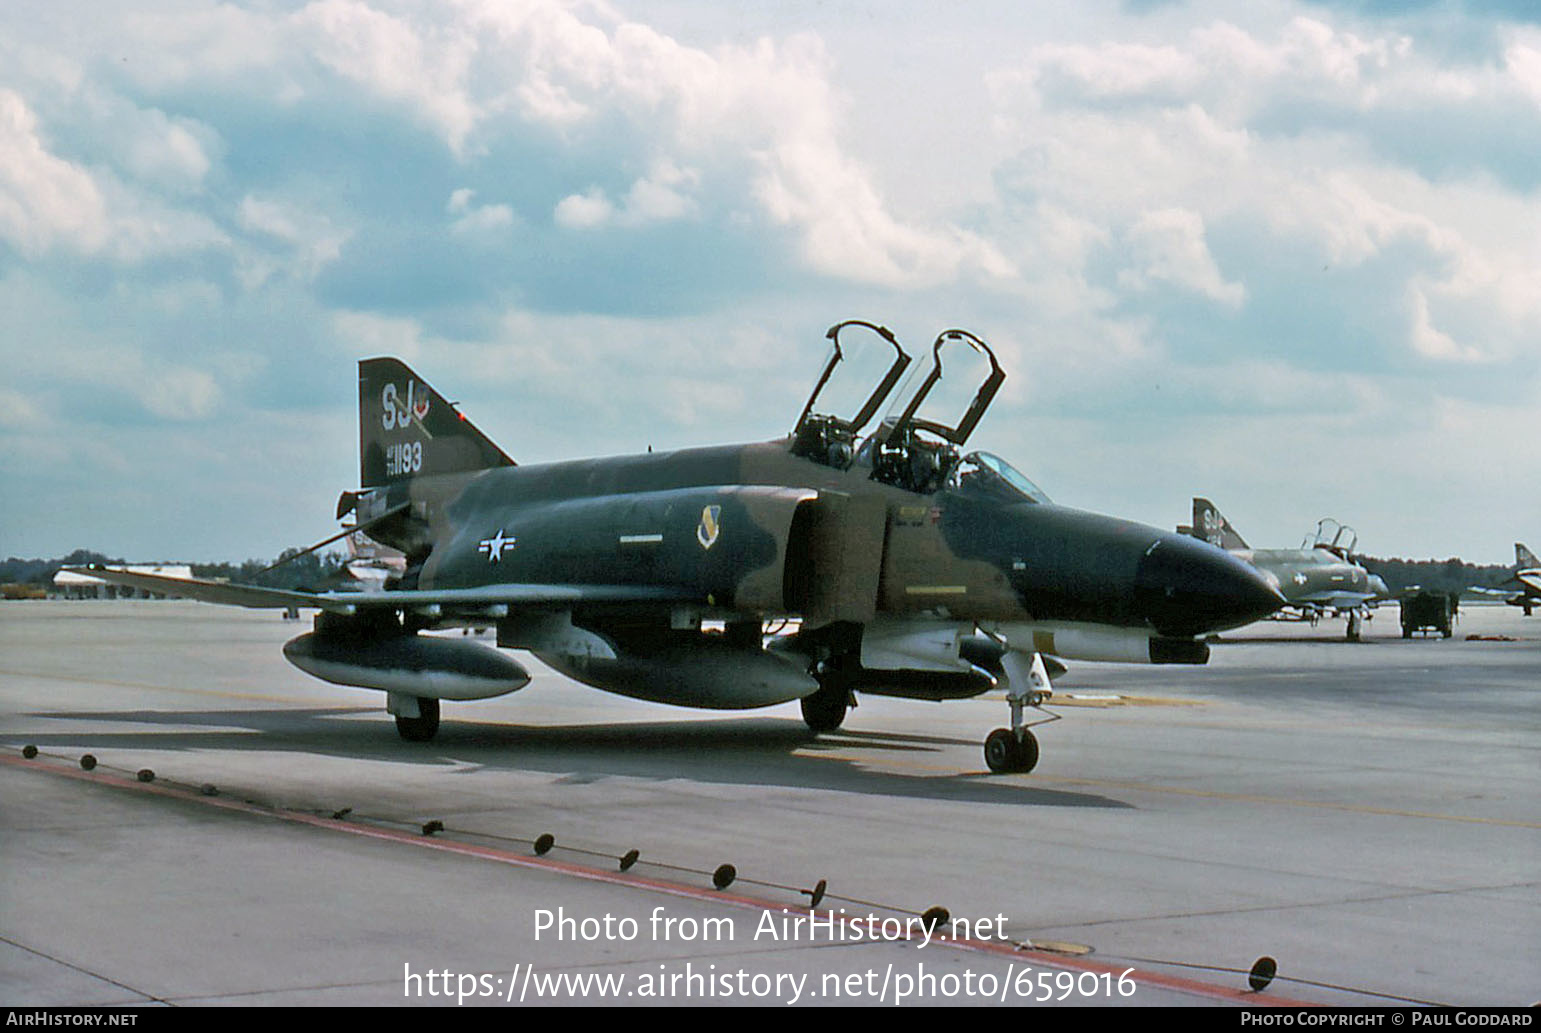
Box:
[359,358,515,487]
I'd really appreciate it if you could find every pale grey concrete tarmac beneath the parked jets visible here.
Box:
[0,601,1541,1007]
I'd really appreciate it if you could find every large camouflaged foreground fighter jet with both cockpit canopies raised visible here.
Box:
[89,328,1282,771]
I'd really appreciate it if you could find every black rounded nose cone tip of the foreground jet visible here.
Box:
[1134,535,1284,637]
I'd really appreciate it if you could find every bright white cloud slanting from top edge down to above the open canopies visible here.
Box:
[217,0,1012,287]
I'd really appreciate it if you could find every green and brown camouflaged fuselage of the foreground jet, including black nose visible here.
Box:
[371,441,1277,656]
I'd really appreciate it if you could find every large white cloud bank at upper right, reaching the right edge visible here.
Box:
[992,19,1541,362]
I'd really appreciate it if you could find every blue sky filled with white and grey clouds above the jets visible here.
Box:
[0,0,1541,563]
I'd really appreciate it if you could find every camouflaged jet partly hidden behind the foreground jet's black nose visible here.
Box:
[1177,498,1392,641]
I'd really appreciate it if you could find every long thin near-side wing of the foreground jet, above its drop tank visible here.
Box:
[66,566,700,614]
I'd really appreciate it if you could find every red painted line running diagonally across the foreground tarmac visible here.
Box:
[0,757,1321,1008]
